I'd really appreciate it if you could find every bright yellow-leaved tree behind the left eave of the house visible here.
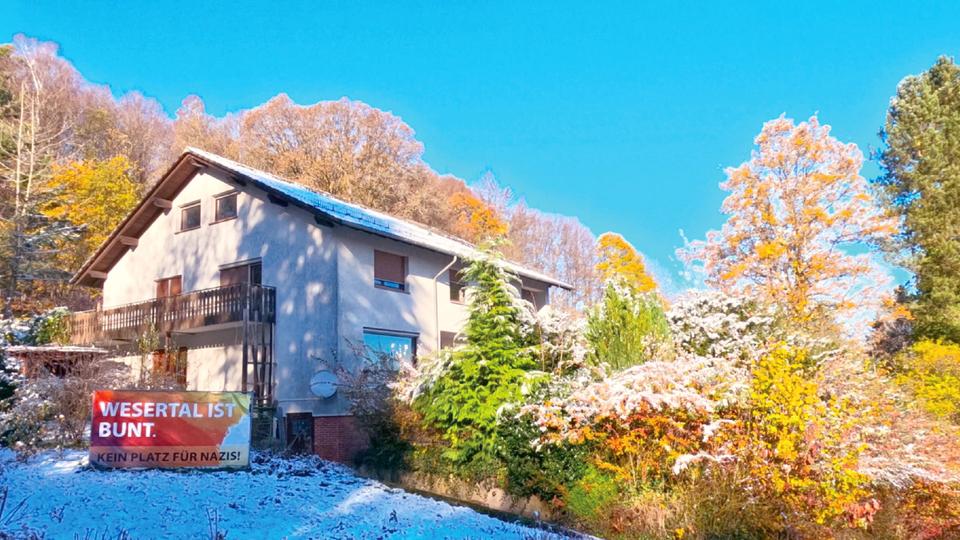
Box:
[44,156,139,270]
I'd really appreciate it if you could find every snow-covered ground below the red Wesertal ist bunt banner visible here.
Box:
[0,449,557,540]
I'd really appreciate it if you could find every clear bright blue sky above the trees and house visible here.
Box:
[0,0,960,294]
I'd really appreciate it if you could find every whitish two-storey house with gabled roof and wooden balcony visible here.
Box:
[71,148,570,460]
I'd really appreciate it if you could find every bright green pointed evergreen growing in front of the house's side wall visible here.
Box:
[415,247,537,465]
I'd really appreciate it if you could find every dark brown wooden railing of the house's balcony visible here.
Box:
[70,283,277,345]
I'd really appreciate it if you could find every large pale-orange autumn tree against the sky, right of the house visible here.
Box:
[678,116,896,323]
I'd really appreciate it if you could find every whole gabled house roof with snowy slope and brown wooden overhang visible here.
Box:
[72,148,573,289]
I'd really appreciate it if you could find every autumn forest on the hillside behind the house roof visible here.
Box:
[0,36,616,318]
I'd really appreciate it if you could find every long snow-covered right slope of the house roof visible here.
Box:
[186,148,573,289]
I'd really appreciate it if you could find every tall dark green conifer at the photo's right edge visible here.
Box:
[876,57,960,342]
